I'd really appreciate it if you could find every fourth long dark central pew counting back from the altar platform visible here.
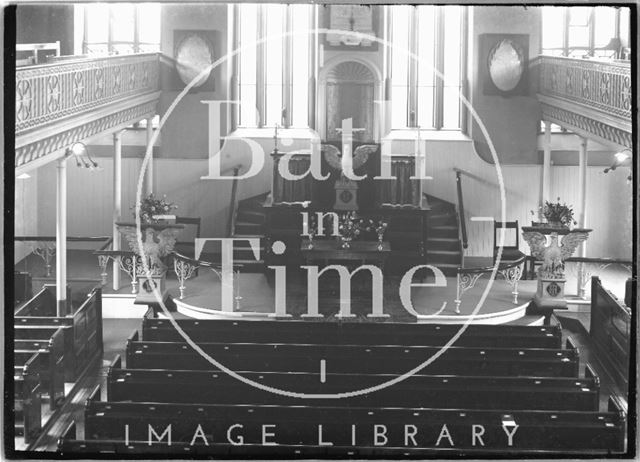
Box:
[84,387,626,452]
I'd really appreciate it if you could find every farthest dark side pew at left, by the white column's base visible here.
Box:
[15,287,102,382]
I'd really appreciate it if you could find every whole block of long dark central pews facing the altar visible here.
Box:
[59,317,626,458]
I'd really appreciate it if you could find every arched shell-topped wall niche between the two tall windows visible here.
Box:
[316,54,383,142]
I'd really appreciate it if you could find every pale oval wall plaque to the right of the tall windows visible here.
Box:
[488,39,526,92]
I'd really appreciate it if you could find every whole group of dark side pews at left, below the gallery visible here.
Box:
[13,286,102,446]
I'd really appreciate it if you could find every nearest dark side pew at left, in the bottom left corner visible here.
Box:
[13,354,42,444]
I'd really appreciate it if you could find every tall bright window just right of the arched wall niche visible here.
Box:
[386,5,466,130]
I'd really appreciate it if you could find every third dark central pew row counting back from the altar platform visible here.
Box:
[107,357,600,411]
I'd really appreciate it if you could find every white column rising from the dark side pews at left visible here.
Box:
[56,156,67,316]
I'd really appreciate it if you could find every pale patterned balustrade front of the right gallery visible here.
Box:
[538,56,631,119]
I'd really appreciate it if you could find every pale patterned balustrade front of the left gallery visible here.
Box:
[15,53,159,136]
